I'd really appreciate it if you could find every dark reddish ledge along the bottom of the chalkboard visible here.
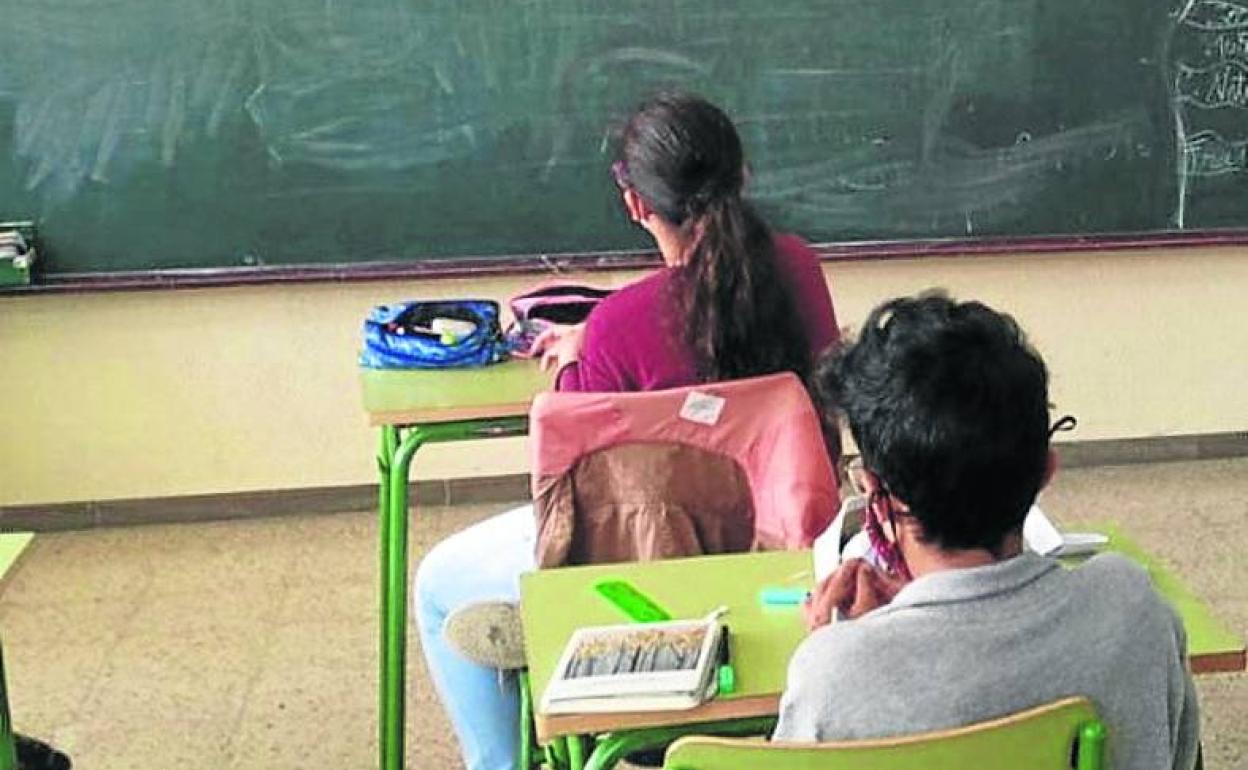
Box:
[7,230,1248,296]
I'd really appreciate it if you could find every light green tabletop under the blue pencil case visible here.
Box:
[359,359,552,426]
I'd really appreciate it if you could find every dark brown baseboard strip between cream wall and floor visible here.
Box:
[0,432,1248,532]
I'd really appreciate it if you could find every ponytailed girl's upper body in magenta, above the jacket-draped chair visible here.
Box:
[534,94,836,391]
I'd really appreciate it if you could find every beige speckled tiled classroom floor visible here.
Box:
[0,459,1248,770]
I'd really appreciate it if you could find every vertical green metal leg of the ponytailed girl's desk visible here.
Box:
[379,427,424,770]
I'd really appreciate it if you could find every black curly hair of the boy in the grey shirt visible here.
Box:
[816,292,1050,554]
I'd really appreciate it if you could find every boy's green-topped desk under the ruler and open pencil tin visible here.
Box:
[520,527,1244,770]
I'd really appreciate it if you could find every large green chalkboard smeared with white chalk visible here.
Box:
[0,0,1248,273]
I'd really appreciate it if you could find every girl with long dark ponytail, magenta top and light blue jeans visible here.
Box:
[416,95,836,770]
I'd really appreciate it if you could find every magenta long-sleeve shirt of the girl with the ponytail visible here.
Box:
[558,235,837,393]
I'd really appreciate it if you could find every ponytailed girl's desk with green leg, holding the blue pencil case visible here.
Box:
[361,361,550,770]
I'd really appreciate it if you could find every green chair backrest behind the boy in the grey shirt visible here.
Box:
[663,698,1106,770]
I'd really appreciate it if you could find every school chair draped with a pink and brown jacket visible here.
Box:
[448,373,840,770]
